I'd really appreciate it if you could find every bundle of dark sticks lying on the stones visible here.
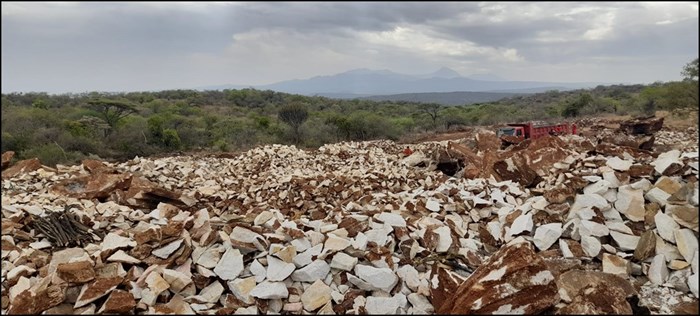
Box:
[32,208,99,247]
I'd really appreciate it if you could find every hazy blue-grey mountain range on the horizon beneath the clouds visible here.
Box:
[200,67,602,102]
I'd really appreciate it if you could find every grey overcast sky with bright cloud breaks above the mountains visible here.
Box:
[2,2,699,93]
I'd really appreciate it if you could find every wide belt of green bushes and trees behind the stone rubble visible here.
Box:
[2,59,698,165]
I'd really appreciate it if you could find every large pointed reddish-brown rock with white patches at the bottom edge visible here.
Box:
[434,242,557,314]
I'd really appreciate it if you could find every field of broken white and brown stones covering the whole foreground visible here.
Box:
[0,118,698,314]
